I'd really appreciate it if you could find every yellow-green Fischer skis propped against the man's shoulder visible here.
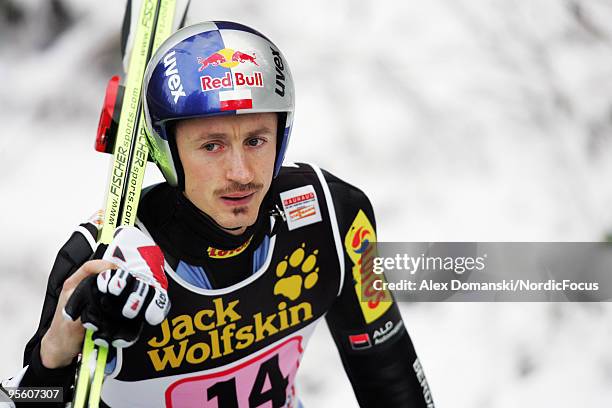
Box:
[72,0,188,408]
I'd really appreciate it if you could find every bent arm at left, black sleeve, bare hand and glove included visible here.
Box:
[1,218,170,407]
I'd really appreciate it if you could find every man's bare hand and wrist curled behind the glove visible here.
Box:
[40,259,116,368]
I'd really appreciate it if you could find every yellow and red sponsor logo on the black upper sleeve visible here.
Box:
[344,210,393,324]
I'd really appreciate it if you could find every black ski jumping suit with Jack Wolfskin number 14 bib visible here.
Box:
[4,164,434,408]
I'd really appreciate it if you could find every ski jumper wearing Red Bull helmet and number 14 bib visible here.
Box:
[4,22,433,408]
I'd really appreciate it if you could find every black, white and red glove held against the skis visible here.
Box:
[64,227,170,347]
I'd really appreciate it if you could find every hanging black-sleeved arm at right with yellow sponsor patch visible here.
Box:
[324,172,434,408]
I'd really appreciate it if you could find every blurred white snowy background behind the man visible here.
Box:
[0,0,612,408]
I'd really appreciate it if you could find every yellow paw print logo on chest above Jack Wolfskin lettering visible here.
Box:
[274,243,319,300]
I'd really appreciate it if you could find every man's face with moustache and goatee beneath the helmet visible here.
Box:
[176,113,278,234]
